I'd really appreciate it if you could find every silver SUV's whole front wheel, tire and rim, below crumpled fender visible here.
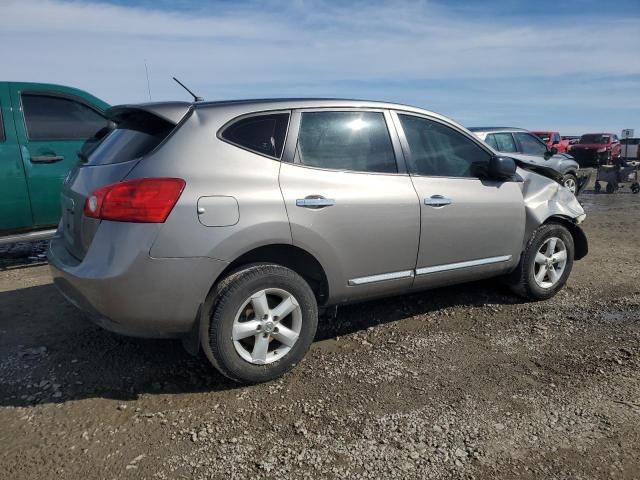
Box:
[507,223,575,300]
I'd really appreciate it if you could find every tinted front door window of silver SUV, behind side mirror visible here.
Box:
[398,115,490,177]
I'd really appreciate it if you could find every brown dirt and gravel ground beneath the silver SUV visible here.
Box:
[0,192,640,480]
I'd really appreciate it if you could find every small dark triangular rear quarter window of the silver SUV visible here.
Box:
[222,113,289,158]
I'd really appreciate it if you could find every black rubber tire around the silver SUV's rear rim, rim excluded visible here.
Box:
[202,264,318,384]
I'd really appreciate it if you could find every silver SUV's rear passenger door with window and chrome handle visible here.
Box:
[280,110,420,302]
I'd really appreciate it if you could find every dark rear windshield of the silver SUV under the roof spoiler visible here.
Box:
[87,112,175,165]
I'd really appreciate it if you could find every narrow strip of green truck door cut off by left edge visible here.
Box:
[0,83,31,233]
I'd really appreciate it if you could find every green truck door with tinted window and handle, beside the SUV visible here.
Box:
[11,84,108,226]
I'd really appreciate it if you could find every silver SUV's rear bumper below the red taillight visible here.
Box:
[48,222,227,338]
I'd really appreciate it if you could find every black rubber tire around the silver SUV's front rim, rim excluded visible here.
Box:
[507,223,575,300]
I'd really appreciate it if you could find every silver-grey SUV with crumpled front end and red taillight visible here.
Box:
[49,100,587,383]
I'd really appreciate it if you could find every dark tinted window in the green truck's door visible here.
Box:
[22,94,107,140]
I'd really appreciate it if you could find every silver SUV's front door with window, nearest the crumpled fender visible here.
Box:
[394,112,525,288]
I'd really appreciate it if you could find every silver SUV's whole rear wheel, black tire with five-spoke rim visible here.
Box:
[202,264,318,383]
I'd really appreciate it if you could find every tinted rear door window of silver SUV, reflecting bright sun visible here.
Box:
[295,112,398,173]
